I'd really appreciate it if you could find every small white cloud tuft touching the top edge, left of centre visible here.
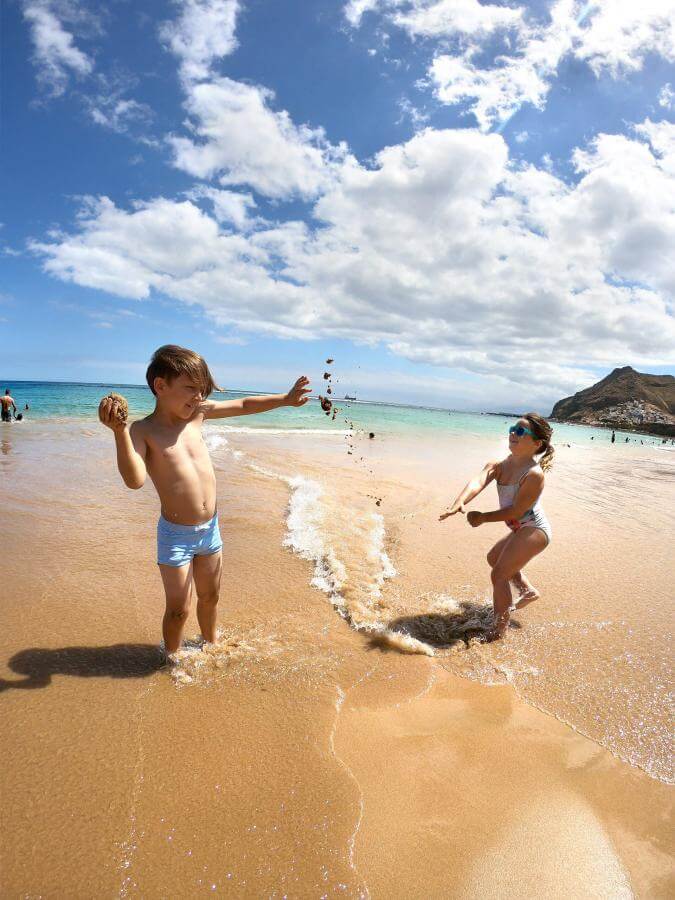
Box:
[160,0,239,81]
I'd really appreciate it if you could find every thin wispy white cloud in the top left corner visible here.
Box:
[23,0,94,97]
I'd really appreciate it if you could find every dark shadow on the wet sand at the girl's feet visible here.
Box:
[371,600,522,649]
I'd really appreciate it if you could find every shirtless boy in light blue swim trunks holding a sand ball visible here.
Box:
[98,344,310,655]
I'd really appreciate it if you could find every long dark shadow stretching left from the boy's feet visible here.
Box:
[0,644,165,691]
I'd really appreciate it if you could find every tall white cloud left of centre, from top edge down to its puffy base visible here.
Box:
[160,0,346,200]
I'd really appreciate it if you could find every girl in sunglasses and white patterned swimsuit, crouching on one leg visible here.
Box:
[439,413,554,641]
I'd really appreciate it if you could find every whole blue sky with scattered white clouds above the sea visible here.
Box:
[0,0,675,414]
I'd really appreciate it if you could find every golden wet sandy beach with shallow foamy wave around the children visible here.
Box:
[0,421,675,898]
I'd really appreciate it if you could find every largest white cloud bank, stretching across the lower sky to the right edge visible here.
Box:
[32,122,675,396]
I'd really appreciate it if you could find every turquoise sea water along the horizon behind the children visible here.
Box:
[2,381,661,446]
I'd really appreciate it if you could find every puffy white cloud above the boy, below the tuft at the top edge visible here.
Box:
[168,78,346,198]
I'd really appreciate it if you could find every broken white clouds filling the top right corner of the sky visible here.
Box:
[354,0,675,130]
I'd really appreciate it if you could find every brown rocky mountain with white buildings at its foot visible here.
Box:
[551,366,675,437]
